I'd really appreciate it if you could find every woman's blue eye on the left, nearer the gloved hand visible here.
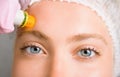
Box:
[21,46,44,55]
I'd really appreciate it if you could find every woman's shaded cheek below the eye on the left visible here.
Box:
[13,59,47,77]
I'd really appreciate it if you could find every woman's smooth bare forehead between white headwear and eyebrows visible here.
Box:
[18,1,108,43]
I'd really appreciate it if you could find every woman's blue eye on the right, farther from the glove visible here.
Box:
[77,48,96,58]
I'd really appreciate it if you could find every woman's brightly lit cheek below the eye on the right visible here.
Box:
[72,51,113,77]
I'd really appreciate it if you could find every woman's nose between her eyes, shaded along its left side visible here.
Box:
[50,49,65,77]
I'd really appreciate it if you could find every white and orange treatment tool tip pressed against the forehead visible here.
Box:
[14,10,35,28]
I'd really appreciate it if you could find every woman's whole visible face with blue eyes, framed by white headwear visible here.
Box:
[13,0,113,77]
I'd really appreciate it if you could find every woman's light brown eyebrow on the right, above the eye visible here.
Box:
[68,33,107,45]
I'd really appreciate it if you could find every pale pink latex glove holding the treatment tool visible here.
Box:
[0,0,30,33]
